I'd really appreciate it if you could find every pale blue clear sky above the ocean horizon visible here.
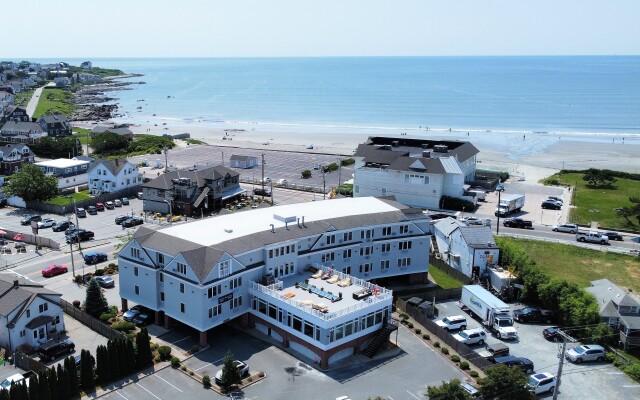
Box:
[6,0,640,59]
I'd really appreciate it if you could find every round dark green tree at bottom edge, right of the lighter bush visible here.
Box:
[480,364,535,400]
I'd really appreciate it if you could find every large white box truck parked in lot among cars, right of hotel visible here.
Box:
[460,285,518,339]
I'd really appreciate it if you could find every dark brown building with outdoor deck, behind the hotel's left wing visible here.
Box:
[142,166,246,215]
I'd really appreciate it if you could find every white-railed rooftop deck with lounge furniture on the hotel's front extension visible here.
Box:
[250,266,392,321]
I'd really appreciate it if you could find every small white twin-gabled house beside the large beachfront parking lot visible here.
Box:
[89,159,142,195]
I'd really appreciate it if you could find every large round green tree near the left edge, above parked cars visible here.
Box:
[3,164,58,201]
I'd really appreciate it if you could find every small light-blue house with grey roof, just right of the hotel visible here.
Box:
[432,217,500,278]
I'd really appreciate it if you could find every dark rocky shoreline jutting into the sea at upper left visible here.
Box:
[71,74,145,123]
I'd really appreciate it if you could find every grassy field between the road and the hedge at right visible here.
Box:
[500,237,640,292]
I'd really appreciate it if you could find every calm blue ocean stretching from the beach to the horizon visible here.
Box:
[38,56,640,138]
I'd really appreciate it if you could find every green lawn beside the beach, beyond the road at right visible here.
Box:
[546,173,640,231]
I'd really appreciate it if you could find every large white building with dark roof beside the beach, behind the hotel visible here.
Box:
[353,137,478,209]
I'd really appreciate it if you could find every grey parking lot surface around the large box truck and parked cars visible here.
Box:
[437,301,640,400]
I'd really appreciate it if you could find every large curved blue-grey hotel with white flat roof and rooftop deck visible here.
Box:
[118,197,430,367]
